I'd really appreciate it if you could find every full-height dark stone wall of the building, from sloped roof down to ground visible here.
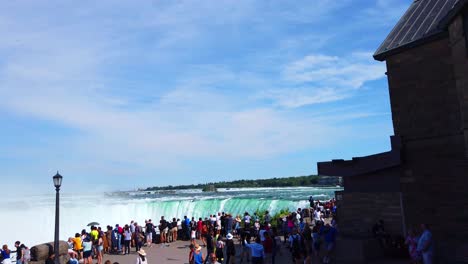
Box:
[387,13,468,263]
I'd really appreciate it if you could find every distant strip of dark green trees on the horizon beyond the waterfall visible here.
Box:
[145,175,320,191]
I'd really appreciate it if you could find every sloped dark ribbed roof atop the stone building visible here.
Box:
[374,0,460,61]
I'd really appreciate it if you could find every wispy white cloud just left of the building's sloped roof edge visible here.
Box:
[257,52,385,108]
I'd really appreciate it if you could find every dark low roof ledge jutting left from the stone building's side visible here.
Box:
[317,136,401,177]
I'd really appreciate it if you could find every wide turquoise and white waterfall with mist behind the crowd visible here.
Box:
[0,187,342,246]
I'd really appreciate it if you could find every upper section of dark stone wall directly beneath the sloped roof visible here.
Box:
[387,38,461,140]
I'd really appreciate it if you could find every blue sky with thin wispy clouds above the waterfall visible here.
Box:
[0,0,411,192]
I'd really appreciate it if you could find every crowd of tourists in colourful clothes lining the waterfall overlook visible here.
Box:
[56,197,337,264]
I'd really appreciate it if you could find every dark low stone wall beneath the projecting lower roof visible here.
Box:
[336,191,403,237]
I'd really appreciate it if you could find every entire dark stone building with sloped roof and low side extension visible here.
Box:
[318,0,468,263]
